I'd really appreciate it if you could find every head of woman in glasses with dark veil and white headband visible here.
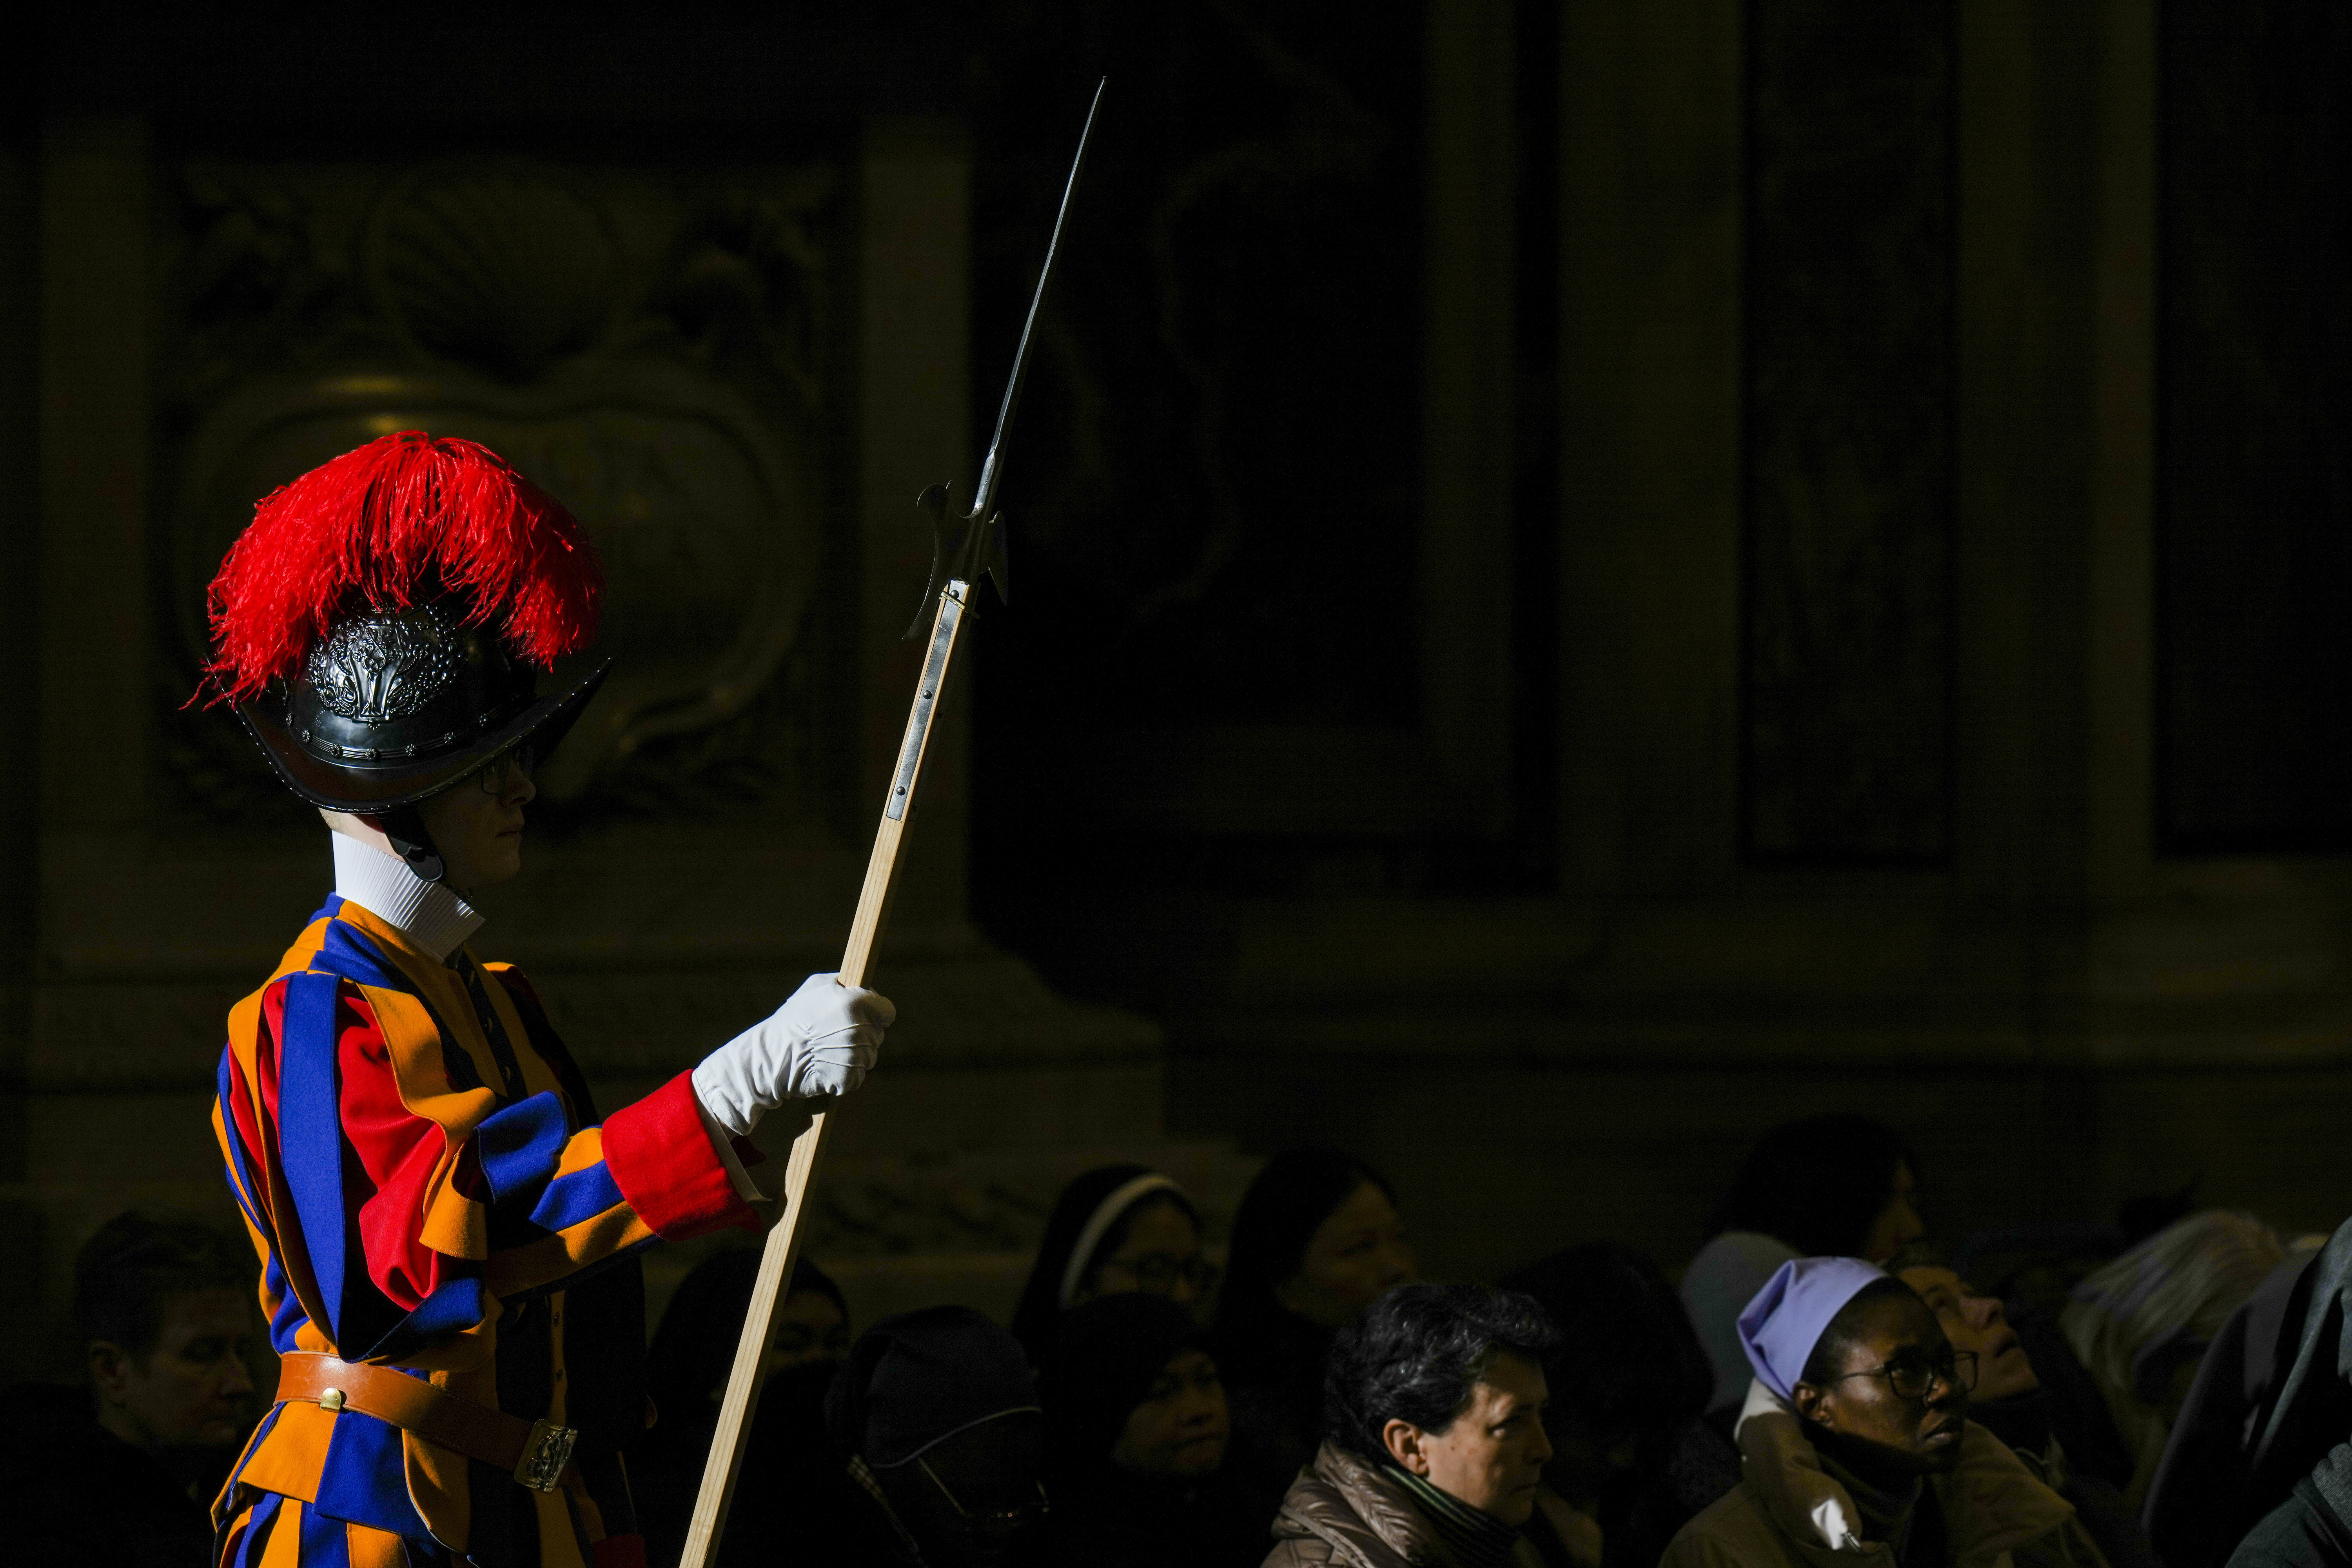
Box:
[1014,1166,1209,1368]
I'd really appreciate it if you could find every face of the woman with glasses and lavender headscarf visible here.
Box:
[1792,1293,1969,1472]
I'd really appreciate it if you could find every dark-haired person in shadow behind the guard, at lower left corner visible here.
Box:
[0,1210,259,1568]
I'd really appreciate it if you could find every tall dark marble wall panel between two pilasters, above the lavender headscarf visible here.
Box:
[1740,0,1955,863]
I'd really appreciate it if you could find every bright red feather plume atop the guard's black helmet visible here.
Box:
[205,430,604,703]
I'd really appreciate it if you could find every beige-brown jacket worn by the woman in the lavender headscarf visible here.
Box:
[1661,1382,2107,1568]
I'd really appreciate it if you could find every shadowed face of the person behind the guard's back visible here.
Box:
[89,1286,254,1450]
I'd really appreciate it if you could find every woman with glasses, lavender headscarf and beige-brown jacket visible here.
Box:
[1661,1258,2107,1568]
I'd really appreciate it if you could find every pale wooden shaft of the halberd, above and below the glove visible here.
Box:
[680,578,969,1568]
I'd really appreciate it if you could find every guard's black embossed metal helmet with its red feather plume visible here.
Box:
[205,430,609,879]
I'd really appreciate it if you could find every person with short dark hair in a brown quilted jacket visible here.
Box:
[1265,1286,1555,1568]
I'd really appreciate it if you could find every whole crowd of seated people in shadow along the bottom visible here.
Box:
[18,1117,2352,1568]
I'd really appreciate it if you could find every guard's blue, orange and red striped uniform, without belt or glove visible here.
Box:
[214,884,757,1568]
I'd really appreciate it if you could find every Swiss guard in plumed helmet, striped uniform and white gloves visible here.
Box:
[193,430,894,1568]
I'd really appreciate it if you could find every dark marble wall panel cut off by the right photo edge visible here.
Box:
[2157,0,2352,853]
